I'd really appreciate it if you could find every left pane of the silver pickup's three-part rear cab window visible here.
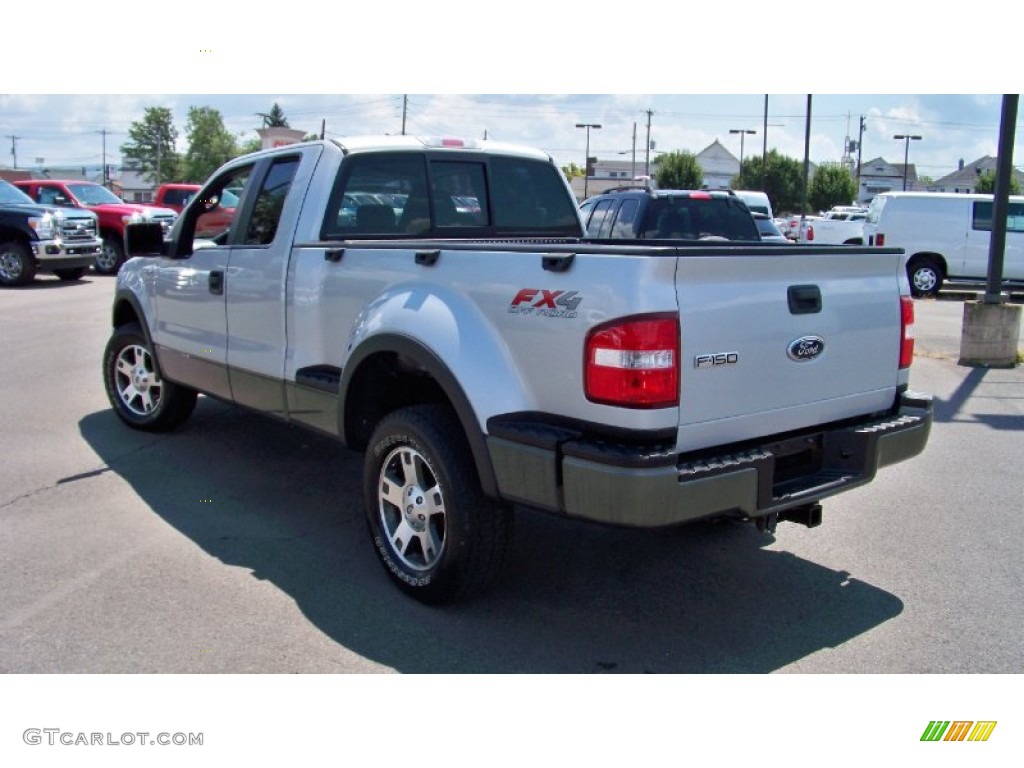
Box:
[321,154,430,240]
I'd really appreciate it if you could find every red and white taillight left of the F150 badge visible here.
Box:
[584,314,680,409]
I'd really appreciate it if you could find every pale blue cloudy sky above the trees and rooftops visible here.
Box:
[0,93,1011,178]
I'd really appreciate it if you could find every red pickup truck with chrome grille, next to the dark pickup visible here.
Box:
[14,179,177,274]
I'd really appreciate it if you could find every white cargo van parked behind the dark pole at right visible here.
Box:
[864,193,1024,296]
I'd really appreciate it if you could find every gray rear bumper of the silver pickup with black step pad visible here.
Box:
[487,393,932,527]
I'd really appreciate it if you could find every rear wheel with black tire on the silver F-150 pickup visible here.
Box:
[364,404,513,604]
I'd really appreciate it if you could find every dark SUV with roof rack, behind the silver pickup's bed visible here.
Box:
[580,187,761,242]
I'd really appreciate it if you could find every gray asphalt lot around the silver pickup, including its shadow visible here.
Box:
[0,275,1024,673]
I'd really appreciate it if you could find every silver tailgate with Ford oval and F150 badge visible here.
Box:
[677,249,905,452]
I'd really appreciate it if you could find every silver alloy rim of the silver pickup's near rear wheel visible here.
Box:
[377,445,445,571]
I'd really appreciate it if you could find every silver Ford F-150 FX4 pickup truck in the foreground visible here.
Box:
[102,136,932,603]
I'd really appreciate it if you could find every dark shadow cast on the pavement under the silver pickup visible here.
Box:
[79,398,903,674]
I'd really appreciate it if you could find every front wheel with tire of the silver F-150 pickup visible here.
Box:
[103,323,196,432]
